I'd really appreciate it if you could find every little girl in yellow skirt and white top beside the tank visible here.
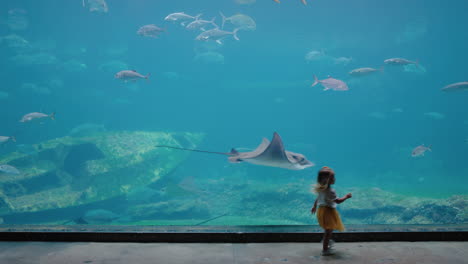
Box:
[311,167,352,256]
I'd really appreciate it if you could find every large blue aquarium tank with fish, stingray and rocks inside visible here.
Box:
[0,0,468,227]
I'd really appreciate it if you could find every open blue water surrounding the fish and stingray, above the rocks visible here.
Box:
[0,0,468,226]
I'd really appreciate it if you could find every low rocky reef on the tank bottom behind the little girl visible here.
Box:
[221,183,468,224]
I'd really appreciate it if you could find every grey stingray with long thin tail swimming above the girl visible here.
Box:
[157,132,315,170]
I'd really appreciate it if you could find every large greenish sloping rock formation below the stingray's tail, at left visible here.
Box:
[0,131,203,215]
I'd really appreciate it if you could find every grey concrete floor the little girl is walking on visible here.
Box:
[0,242,468,264]
